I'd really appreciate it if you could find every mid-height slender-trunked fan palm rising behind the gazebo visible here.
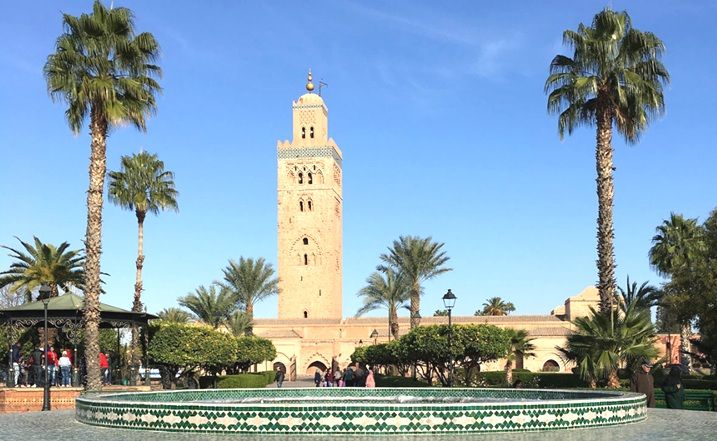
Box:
[108,152,179,375]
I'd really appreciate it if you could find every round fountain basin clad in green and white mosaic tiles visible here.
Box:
[76,388,647,434]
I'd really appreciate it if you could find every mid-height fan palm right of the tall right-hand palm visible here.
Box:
[649,213,707,368]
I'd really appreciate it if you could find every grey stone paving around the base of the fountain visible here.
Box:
[0,409,717,441]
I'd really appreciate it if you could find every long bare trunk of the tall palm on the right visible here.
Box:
[595,104,617,312]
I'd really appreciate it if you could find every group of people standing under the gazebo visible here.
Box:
[12,343,73,387]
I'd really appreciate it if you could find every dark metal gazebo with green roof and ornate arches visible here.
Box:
[0,293,157,387]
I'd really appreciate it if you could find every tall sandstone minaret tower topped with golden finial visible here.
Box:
[277,71,343,319]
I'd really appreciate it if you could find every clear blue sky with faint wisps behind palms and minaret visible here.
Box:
[0,0,717,317]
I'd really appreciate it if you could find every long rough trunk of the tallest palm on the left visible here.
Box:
[84,107,107,391]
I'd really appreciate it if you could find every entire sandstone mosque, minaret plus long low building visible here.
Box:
[254,72,676,379]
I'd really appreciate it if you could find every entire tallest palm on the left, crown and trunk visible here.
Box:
[44,0,161,391]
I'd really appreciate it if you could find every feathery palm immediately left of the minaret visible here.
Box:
[219,257,279,335]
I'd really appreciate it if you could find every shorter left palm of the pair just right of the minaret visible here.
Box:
[356,268,411,340]
